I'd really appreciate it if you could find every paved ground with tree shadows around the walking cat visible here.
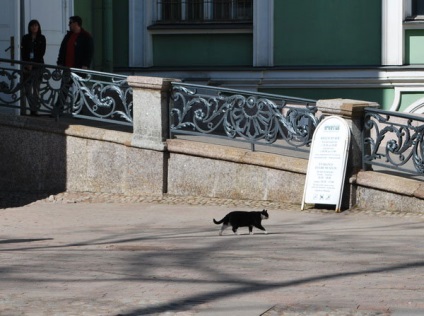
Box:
[0,197,424,316]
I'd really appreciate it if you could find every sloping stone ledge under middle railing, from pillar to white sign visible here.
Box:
[167,139,308,174]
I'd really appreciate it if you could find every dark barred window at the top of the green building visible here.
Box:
[156,0,253,23]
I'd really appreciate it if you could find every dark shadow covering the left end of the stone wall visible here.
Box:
[0,115,67,208]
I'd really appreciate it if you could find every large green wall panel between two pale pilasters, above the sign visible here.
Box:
[274,0,381,66]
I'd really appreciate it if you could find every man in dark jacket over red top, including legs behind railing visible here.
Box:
[54,16,94,116]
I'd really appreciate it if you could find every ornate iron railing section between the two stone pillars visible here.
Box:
[170,82,320,151]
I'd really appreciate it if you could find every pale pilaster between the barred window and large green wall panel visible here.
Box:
[253,0,274,67]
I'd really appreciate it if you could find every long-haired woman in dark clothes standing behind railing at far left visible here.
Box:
[21,20,46,115]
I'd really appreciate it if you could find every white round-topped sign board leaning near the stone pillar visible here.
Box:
[302,116,350,212]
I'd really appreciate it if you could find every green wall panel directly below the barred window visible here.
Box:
[153,34,253,67]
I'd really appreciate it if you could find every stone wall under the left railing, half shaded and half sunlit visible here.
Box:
[0,116,166,198]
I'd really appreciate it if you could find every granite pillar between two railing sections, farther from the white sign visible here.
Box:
[128,76,178,151]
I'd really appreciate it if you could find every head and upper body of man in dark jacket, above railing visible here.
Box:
[57,16,94,69]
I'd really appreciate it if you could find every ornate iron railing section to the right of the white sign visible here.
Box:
[362,108,424,175]
